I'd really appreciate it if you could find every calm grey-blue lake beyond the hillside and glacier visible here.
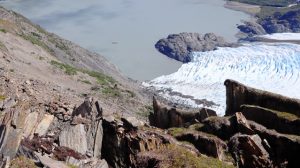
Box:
[0,0,249,81]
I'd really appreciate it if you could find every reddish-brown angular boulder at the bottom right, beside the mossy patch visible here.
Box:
[229,134,273,168]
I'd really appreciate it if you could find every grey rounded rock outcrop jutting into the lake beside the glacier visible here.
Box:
[155,32,235,63]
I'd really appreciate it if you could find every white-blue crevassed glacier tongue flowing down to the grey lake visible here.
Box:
[143,42,300,115]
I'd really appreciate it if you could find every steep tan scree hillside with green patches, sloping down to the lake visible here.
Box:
[0,7,149,117]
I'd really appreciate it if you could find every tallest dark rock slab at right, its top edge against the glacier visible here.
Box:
[224,80,300,117]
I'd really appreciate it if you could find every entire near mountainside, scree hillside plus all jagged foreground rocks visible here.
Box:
[0,5,300,168]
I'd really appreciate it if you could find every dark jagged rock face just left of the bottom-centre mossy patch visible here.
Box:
[102,117,178,167]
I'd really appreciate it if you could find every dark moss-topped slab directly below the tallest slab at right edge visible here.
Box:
[242,105,300,135]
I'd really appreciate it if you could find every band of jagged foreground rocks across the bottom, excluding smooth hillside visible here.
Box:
[0,77,300,168]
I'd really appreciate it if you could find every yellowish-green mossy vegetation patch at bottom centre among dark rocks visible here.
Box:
[157,145,234,168]
